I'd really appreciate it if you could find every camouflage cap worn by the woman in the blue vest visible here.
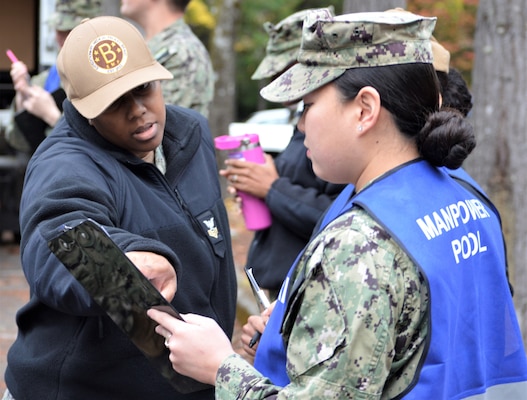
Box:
[260,12,436,103]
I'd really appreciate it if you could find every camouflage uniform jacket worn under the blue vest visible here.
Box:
[216,207,428,399]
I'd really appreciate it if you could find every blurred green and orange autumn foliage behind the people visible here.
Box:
[186,0,478,121]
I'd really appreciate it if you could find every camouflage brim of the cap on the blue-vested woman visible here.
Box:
[260,64,347,103]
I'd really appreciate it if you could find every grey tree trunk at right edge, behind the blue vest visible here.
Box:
[465,0,527,344]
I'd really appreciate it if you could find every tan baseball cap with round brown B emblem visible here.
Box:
[57,16,173,119]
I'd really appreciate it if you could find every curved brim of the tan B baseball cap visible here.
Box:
[71,62,173,119]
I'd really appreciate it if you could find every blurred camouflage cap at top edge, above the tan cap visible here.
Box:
[48,0,102,31]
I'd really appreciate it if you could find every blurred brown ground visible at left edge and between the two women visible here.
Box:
[0,200,257,395]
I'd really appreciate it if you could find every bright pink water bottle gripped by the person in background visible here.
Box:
[214,133,271,231]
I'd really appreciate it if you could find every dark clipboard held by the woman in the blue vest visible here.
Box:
[48,219,212,393]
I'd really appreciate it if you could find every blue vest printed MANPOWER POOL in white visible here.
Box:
[255,161,527,400]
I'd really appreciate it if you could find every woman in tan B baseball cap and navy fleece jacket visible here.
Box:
[5,17,236,400]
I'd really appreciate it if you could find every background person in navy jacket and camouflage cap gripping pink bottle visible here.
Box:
[220,8,344,308]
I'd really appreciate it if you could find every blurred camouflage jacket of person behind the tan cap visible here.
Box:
[148,18,214,117]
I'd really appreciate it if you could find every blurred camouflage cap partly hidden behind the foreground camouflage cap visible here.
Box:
[251,6,334,80]
